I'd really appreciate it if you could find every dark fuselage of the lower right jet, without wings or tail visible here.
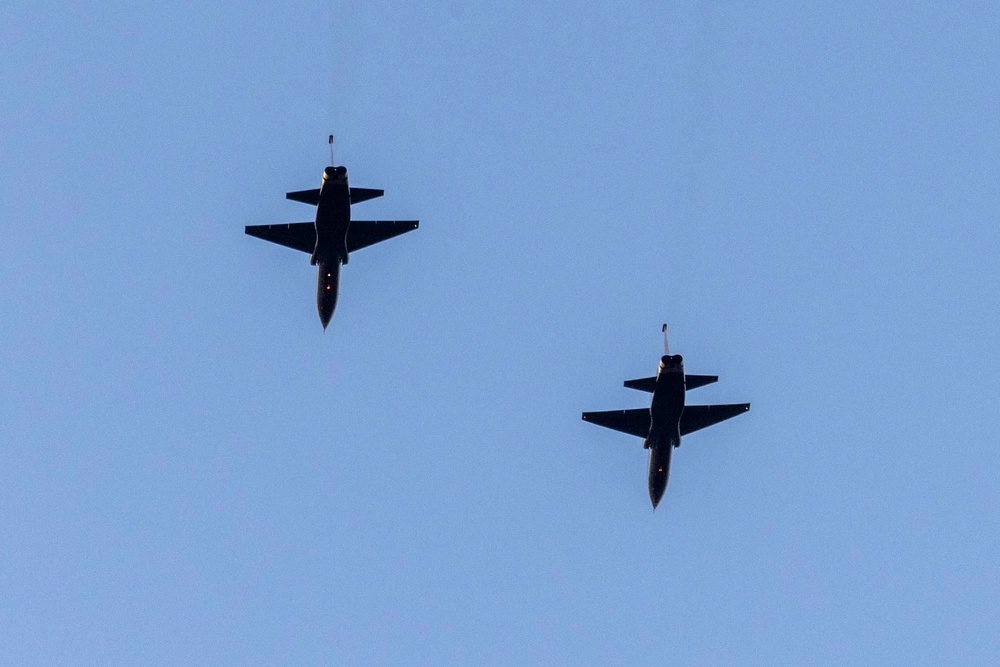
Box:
[642,354,684,509]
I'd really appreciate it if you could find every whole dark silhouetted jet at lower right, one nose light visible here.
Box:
[583,324,750,510]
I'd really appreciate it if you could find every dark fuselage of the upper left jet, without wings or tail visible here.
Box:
[310,167,351,329]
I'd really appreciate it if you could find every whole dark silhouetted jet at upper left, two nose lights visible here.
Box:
[246,137,419,329]
